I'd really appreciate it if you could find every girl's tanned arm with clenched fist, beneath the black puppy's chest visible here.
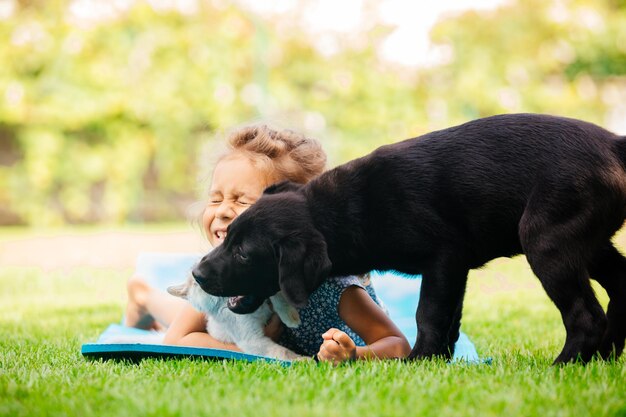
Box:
[317,286,411,364]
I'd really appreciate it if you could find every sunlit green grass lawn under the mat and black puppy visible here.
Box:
[0,228,626,417]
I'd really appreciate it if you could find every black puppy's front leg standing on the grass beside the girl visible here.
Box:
[409,252,469,359]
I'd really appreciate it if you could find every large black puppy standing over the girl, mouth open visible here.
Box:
[193,114,626,362]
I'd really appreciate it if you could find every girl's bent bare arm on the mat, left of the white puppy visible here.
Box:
[163,304,241,352]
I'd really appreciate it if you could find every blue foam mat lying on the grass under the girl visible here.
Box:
[81,252,480,365]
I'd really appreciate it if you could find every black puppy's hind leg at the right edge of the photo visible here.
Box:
[589,242,626,359]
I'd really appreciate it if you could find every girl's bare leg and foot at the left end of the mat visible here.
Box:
[124,275,187,330]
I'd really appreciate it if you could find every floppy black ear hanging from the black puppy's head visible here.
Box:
[278,231,332,307]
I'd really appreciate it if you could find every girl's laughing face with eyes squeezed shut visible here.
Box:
[202,154,269,247]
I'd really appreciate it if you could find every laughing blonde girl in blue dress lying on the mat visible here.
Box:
[126,126,410,364]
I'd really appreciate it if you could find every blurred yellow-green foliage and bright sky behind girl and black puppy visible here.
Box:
[0,0,626,228]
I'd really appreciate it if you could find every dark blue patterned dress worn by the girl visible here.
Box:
[278,276,384,356]
